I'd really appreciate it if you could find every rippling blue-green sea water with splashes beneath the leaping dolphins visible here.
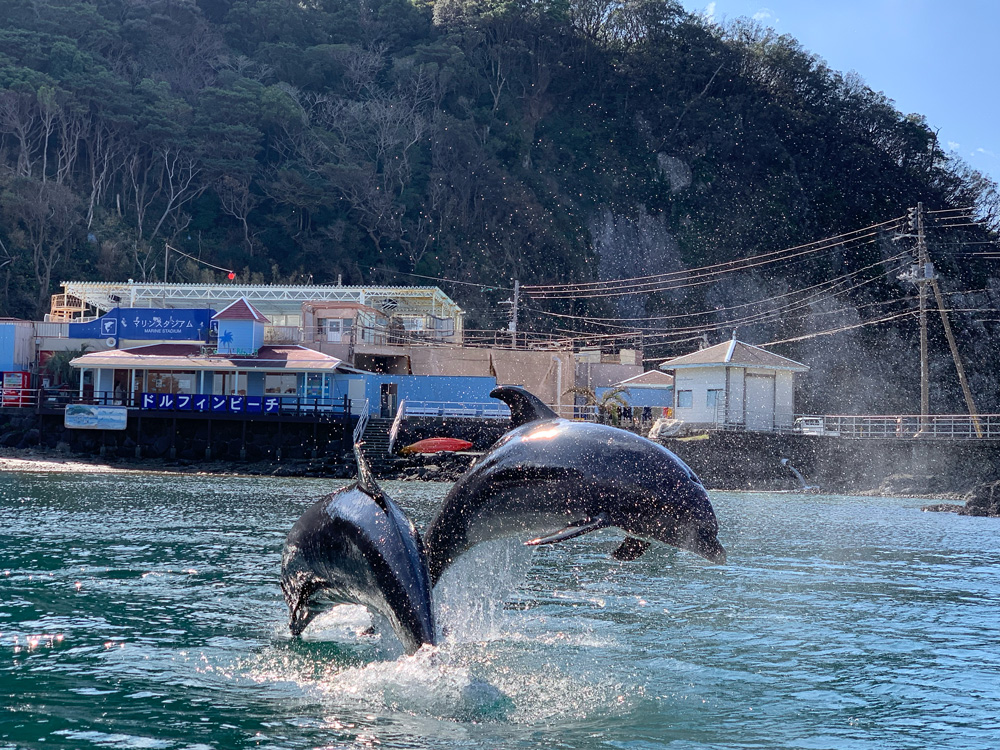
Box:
[0,473,1000,750]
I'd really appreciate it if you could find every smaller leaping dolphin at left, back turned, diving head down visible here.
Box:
[281,445,436,654]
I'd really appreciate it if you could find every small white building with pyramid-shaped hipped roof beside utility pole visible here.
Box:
[660,339,809,431]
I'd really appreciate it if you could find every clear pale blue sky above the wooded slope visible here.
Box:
[681,0,1000,188]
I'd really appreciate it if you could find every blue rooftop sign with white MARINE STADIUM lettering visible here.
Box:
[68,307,215,341]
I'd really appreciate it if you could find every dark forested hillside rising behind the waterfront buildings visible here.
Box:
[0,0,1000,412]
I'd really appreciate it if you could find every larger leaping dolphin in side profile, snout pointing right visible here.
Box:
[424,386,726,584]
